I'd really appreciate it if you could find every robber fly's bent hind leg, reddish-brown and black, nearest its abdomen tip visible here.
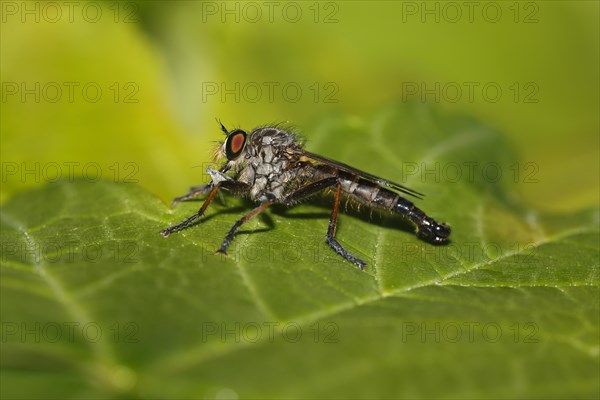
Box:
[283,177,367,270]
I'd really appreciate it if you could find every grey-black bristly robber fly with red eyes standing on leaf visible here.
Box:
[161,121,450,270]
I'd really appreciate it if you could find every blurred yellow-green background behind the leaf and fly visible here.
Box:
[0,1,599,211]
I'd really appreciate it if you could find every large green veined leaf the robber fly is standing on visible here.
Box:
[1,104,600,398]
